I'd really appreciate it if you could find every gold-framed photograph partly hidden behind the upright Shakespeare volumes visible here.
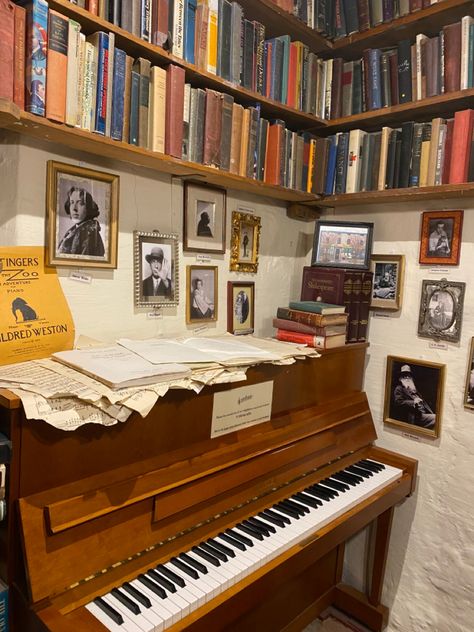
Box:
[370,255,405,310]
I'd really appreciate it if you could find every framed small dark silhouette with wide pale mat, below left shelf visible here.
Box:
[183,182,226,253]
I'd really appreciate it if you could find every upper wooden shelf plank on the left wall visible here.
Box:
[49,0,326,130]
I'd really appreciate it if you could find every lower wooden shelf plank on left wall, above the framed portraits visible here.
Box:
[0,100,317,204]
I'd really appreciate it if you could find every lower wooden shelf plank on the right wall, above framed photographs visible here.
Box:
[317,182,474,208]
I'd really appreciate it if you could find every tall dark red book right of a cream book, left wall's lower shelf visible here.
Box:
[165,64,184,158]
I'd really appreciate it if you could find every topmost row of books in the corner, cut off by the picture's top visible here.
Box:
[273,0,443,39]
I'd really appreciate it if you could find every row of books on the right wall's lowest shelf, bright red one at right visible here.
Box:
[314,110,474,195]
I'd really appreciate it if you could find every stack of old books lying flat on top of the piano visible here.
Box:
[273,301,348,349]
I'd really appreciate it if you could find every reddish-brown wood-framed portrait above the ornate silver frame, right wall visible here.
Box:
[420,211,464,266]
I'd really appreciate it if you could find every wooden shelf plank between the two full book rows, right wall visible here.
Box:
[324,88,474,135]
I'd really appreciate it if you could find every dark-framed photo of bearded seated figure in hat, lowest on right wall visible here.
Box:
[383,356,445,437]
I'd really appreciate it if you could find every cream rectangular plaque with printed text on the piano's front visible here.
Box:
[211,382,273,438]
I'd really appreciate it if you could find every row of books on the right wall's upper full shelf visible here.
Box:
[323,16,474,119]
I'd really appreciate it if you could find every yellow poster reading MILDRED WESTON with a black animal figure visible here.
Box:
[0,246,74,365]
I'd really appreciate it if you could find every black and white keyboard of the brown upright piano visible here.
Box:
[86,459,403,632]
